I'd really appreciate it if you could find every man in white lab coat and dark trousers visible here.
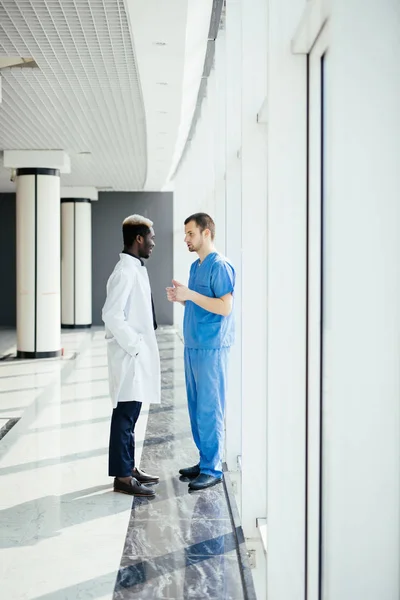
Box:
[102,215,161,497]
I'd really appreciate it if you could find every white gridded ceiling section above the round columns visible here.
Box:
[0,0,147,191]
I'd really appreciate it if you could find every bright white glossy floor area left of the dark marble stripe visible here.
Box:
[0,330,147,600]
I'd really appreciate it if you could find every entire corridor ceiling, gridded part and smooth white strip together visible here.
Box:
[0,0,213,192]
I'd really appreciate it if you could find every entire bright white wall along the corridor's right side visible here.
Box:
[171,0,400,600]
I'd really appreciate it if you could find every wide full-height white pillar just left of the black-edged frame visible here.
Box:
[266,0,310,600]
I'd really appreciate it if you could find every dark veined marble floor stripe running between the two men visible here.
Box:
[113,332,252,600]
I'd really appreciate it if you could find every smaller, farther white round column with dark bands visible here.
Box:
[61,198,92,329]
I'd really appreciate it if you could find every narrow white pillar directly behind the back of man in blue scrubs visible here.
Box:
[225,0,242,471]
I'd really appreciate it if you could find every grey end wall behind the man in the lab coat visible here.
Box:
[92,192,173,325]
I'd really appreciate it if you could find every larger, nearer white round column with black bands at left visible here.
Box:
[17,168,61,358]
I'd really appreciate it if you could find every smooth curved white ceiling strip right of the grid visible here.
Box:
[125,0,213,190]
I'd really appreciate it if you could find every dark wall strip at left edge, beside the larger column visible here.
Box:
[0,194,17,327]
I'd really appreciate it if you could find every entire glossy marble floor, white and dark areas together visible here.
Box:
[0,329,255,600]
